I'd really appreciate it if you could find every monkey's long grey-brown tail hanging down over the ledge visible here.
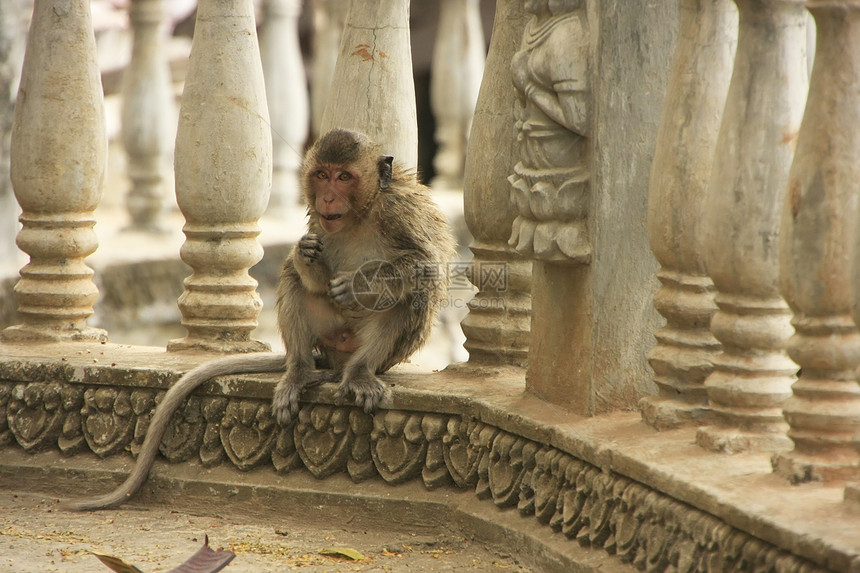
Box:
[60,352,286,511]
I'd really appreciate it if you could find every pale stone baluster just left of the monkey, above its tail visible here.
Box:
[167,0,272,352]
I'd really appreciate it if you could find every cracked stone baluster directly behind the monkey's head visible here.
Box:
[322,0,418,168]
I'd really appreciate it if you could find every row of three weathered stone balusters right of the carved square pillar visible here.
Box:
[642,0,860,496]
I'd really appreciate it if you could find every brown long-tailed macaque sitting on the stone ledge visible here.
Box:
[64,129,455,510]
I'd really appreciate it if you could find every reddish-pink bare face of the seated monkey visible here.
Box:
[310,165,361,233]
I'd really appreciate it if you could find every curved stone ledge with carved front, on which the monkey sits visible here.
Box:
[0,344,860,571]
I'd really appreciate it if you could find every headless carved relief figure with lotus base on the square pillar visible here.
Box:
[508,0,591,264]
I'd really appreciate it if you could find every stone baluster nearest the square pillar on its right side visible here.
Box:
[639,0,737,429]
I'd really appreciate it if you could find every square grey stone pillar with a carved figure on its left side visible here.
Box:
[509,0,677,415]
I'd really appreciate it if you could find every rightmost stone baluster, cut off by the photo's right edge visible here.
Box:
[774,0,860,482]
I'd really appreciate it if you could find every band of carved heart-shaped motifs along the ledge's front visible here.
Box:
[0,382,823,573]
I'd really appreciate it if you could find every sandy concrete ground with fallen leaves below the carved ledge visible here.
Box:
[0,489,530,573]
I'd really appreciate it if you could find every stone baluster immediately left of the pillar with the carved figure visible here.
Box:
[462,0,532,366]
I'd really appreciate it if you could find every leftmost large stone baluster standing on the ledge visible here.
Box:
[2,0,107,341]
